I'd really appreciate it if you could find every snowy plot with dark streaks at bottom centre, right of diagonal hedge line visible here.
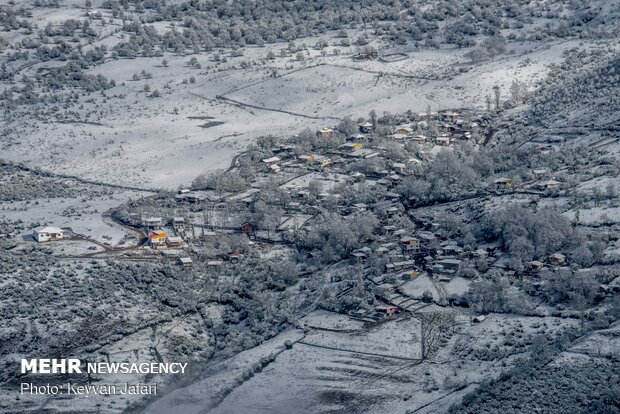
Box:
[209,324,483,414]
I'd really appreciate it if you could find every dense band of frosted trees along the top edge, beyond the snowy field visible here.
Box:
[103,0,599,58]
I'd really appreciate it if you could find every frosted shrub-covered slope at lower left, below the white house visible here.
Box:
[0,243,305,380]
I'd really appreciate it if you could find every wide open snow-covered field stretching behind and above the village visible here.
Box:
[1,32,574,189]
